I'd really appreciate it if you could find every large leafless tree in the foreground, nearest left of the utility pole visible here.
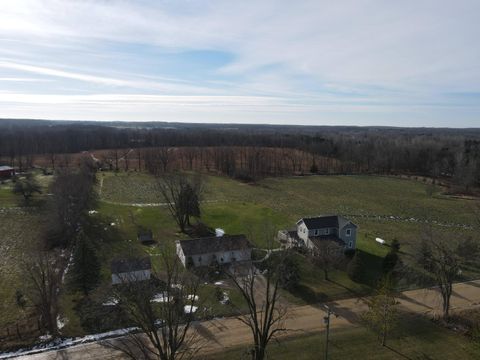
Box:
[227,249,287,360]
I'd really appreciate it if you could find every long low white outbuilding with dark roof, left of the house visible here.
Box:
[176,235,253,267]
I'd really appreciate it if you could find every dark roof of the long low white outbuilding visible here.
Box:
[179,235,252,256]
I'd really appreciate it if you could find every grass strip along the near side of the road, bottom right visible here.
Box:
[204,316,480,360]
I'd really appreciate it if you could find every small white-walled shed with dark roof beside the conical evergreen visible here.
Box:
[111,257,152,285]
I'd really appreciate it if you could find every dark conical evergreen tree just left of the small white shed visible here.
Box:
[72,235,100,295]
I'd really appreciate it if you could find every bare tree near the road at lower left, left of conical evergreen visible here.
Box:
[23,251,63,336]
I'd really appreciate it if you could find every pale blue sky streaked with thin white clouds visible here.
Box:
[0,0,480,127]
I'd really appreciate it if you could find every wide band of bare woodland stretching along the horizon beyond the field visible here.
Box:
[0,122,480,191]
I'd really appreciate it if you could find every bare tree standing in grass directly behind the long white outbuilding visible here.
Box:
[157,174,202,232]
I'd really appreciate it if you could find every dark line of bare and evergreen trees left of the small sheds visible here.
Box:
[14,159,100,336]
